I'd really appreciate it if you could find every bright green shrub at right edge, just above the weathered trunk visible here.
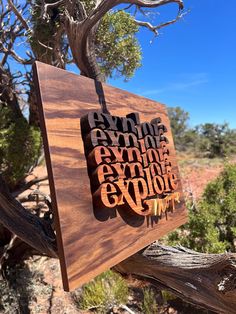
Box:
[168,164,236,253]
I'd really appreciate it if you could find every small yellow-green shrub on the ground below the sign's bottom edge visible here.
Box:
[73,270,128,313]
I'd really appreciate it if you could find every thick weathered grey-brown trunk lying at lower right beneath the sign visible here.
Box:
[114,243,236,314]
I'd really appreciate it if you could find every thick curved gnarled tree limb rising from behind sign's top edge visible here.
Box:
[64,0,183,81]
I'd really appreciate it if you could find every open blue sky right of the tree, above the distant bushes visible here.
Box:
[109,0,236,128]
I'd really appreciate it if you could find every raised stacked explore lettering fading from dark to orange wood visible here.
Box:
[81,111,179,216]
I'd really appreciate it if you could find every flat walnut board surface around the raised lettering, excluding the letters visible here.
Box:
[34,62,187,291]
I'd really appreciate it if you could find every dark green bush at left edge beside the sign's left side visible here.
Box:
[0,106,41,187]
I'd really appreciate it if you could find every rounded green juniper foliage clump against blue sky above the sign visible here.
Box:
[96,11,141,80]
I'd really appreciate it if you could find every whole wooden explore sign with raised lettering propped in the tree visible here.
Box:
[34,62,187,291]
